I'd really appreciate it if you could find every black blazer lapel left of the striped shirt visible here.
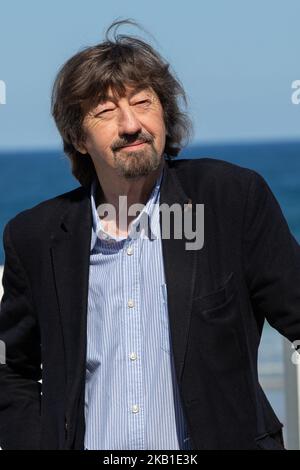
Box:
[51,187,92,434]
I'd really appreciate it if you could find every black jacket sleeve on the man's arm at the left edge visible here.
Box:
[0,222,41,449]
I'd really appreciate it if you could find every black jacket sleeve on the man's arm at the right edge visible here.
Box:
[243,171,300,341]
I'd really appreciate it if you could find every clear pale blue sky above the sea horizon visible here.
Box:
[0,0,300,151]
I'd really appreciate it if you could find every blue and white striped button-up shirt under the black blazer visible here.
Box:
[84,167,189,450]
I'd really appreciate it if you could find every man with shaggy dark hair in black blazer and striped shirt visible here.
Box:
[0,23,300,449]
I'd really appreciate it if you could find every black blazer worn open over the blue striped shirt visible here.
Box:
[0,158,300,449]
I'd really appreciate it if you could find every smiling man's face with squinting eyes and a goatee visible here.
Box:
[80,83,166,178]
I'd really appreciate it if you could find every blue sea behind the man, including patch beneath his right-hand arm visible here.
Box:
[0,140,300,440]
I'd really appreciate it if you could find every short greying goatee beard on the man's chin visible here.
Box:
[114,144,161,179]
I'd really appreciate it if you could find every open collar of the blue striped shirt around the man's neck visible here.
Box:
[90,167,164,250]
